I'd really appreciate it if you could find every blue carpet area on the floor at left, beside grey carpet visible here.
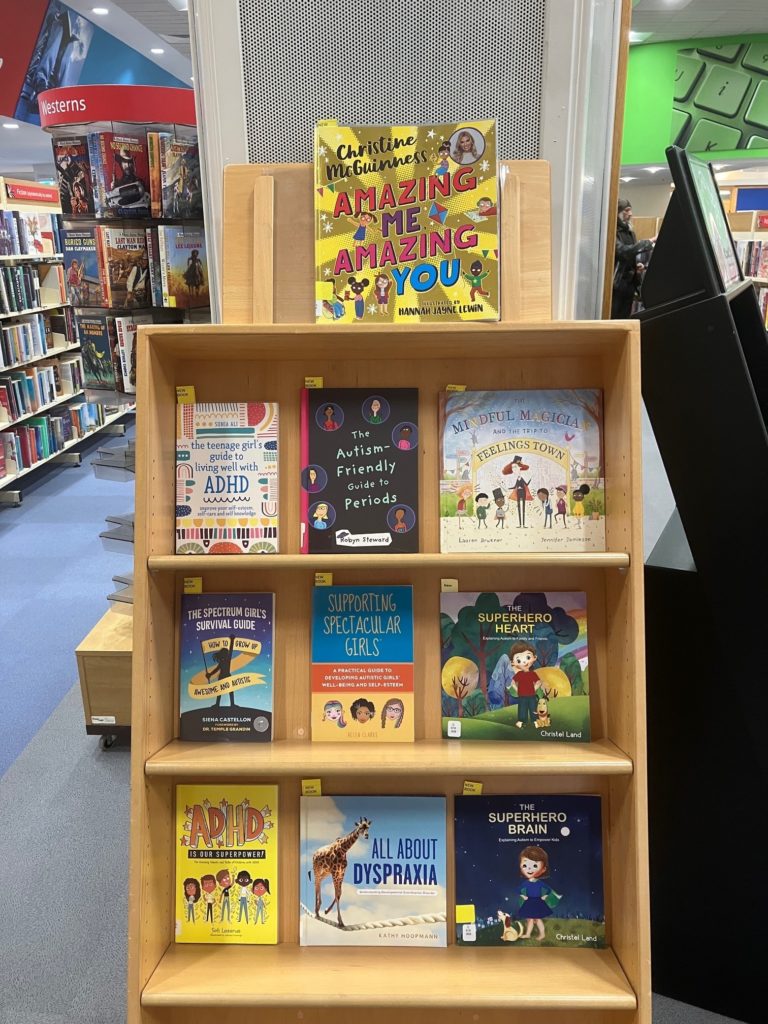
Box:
[0,418,133,776]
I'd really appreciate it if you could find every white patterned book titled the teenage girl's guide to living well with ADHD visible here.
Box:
[176,401,278,555]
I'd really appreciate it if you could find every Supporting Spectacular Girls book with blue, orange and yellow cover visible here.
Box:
[311,587,414,743]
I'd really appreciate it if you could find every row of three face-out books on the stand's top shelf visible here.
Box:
[175,387,605,555]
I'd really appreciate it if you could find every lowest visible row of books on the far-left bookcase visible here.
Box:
[0,401,116,479]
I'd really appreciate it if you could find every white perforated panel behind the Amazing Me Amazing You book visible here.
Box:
[240,0,547,164]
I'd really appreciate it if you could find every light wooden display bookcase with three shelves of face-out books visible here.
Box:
[128,168,650,1024]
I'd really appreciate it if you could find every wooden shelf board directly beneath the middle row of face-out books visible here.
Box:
[144,737,632,778]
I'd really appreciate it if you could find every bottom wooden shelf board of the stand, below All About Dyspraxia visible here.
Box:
[141,943,637,1011]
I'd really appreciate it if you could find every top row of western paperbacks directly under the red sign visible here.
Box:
[53,126,203,219]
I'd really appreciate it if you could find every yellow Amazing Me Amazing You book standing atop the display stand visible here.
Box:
[314,121,499,324]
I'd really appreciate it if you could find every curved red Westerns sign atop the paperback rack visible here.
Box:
[38,85,197,128]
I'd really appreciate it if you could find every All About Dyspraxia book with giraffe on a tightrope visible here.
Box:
[299,797,447,946]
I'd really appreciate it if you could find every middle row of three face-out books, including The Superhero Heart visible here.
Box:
[178,585,592,743]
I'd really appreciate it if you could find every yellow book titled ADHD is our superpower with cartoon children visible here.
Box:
[174,782,279,945]
